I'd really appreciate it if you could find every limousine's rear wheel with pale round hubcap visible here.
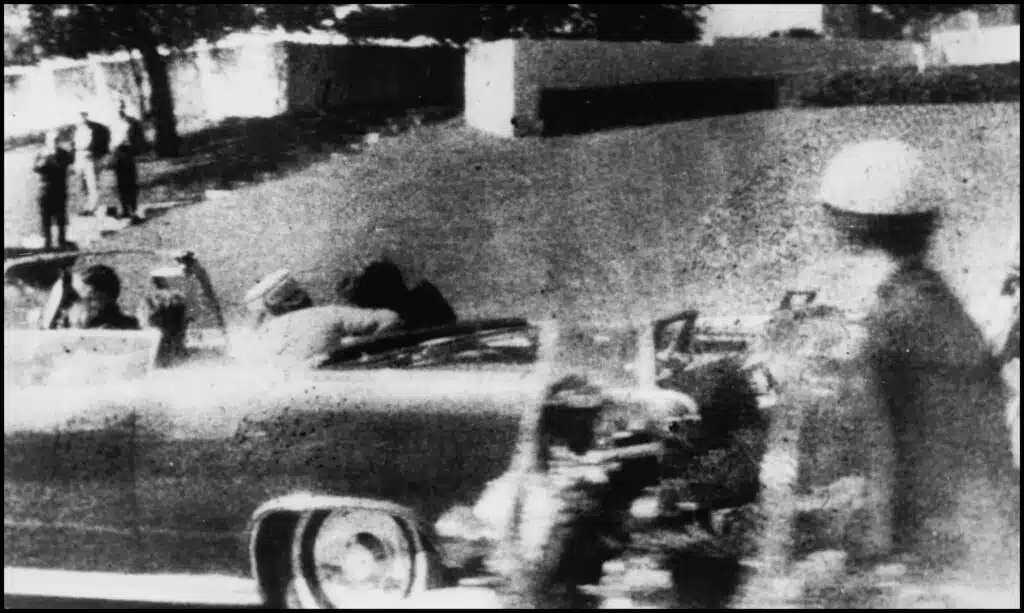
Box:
[288,509,417,609]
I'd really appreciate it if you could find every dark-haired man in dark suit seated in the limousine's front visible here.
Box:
[57,264,140,330]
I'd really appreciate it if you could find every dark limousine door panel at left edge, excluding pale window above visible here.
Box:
[4,388,142,572]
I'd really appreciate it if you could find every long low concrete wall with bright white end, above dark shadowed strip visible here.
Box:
[465,38,922,136]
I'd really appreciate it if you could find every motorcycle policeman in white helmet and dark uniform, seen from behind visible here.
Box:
[782,141,1020,572]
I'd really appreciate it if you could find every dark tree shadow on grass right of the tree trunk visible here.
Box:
[140,106,457,195]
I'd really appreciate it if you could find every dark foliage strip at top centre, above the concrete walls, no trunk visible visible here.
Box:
[336,4,707,47]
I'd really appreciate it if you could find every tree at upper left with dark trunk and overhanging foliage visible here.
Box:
[29,4,334,157]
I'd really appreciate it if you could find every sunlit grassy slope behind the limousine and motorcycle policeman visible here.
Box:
[97,103,1020,329]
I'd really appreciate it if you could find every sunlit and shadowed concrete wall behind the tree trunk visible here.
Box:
[4,42,465,141]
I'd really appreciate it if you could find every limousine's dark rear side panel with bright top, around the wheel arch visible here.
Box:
[128,366,536,575]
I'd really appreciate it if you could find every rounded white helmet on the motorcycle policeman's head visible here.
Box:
[818,140,937,216]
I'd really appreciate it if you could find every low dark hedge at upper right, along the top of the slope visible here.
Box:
[799,62,1021,106]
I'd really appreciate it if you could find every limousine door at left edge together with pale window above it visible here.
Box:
[4,331,158,572]
